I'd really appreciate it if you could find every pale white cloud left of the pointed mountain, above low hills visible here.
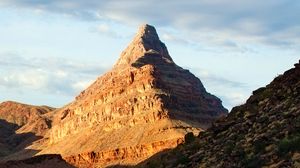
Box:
[0,53,107,96]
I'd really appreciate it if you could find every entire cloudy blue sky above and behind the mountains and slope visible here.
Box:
[0,0,300,109]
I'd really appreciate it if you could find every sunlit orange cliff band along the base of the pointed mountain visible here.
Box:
[64,139,183,167]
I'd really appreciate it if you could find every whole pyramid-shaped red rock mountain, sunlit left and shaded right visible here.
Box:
[11,25,227,166]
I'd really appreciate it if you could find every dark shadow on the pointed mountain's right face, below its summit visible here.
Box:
[131,53,228,129]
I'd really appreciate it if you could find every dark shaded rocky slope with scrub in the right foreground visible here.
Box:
[140,61,300,168]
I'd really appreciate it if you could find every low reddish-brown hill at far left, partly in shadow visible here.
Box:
[0,101,54,160]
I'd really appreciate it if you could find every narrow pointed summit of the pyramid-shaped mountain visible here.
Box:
[115,24,173,68]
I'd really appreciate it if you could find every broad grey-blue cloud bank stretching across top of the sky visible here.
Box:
[0,0,300,51]
